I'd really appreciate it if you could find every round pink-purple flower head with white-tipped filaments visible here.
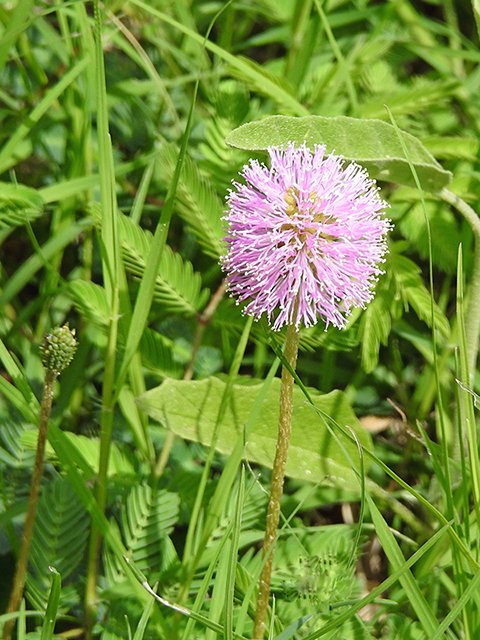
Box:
[221,143,391,330]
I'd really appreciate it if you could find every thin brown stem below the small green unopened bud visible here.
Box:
[3,369,58,640]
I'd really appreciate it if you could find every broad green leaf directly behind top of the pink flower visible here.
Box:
[226,116,452,192]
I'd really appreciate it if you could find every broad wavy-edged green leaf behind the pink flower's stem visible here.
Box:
[137,378,371,491]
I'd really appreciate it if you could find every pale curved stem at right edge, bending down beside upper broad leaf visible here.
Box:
[440,189,480,381]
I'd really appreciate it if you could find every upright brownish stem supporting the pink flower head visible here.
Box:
[253,324,300,640]
